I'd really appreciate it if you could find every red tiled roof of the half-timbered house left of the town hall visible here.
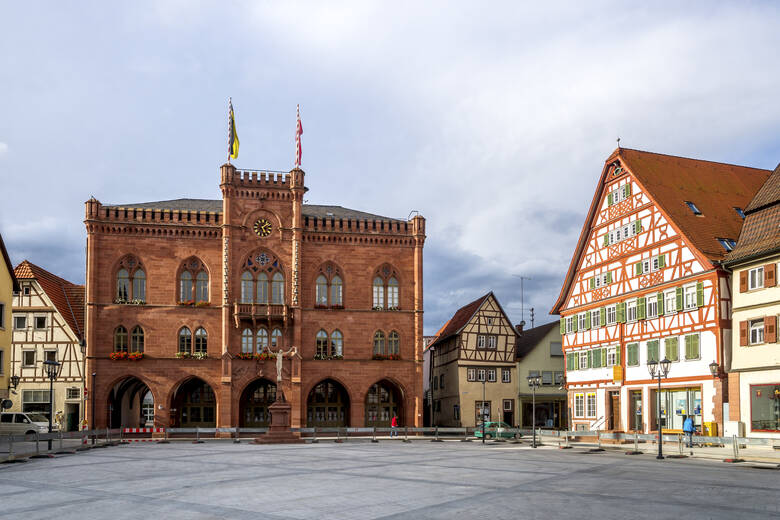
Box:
[14,260,84,339]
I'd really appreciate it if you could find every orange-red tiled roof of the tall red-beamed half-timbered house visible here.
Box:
[550,148,771,314]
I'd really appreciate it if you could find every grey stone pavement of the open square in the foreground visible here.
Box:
[0,440,780,520]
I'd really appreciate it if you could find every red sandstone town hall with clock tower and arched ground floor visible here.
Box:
[85,164,425,427]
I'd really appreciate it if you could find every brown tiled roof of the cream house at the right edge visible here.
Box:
[725,165,780,265]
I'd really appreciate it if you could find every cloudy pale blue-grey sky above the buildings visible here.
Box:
[0,0,780,334]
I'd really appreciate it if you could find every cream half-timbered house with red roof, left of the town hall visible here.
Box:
[11,260,84,430]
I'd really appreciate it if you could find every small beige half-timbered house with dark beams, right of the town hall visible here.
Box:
[428,292,517,427]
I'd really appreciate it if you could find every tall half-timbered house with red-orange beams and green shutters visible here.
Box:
[551,148,770,432]
